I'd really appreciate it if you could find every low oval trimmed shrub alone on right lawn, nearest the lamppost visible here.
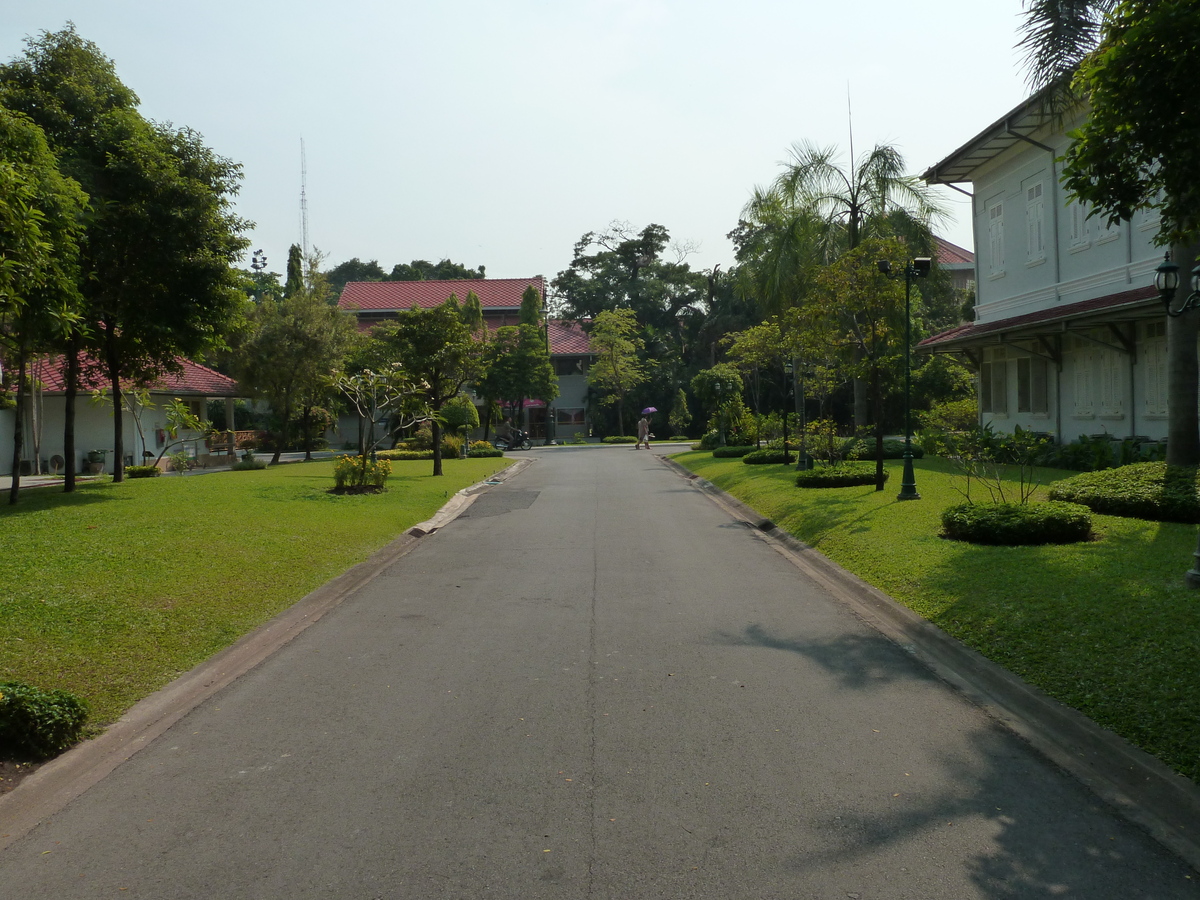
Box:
[942,500,1092,545]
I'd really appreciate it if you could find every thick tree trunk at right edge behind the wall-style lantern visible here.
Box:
[1166,245,1200,466]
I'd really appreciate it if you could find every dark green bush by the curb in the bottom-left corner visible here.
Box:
[0,682,88,758]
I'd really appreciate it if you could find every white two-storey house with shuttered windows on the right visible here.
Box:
[919,96,1168,443]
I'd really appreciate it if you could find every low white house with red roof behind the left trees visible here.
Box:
[0,358,240,475]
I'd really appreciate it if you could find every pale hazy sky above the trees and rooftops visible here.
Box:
[0,0,1028,285]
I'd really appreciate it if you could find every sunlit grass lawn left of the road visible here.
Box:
[0,460,511,725]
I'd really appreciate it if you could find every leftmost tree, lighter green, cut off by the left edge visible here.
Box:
[0,107,88,503]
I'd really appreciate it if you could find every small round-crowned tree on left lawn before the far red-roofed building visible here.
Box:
[371,304,482,475]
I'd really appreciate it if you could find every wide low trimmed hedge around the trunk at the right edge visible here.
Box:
[1050,462,1200,523]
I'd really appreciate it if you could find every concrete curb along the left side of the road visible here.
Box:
[0,460,533,851]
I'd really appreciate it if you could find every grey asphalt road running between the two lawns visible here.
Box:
[0,448,1200,900]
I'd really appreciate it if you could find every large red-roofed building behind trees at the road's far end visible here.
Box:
[337,275,594,440]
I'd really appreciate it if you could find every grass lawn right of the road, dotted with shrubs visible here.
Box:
[674,452,1200,781]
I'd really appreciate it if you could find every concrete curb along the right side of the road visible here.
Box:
[661,457,1200,870]
